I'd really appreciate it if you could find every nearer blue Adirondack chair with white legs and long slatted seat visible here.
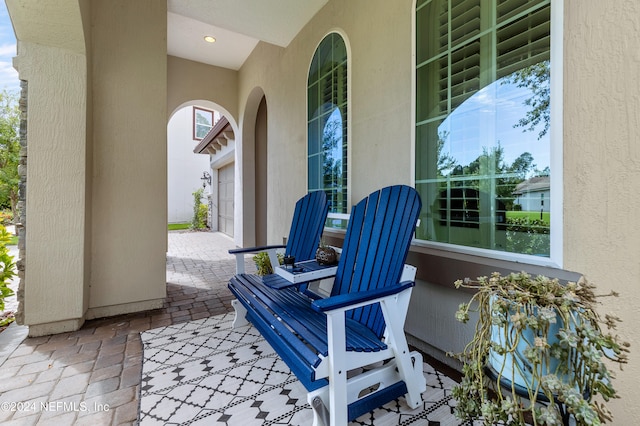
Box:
[229,185,426,426]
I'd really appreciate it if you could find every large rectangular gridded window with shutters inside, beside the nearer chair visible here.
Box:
[416,0,553,257]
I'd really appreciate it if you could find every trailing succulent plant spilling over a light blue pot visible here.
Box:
[449,272,629,425]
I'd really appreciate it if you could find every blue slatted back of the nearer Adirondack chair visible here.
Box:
[331,185,422,338]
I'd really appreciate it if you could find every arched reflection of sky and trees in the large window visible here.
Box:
[424,61,551,256]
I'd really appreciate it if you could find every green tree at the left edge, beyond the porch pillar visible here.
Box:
[0,90,20,221]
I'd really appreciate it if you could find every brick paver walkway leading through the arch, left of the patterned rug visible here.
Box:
[0,232,255,426]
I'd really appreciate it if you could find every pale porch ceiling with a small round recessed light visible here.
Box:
[167,0,328,70]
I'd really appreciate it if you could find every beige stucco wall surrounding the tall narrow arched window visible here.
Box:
[239,0,412,241]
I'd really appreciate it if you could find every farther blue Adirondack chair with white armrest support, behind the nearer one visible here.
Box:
[229,191,329,274]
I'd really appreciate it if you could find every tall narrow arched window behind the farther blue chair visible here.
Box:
[307,33,348,227]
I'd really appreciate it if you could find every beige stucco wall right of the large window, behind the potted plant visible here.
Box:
[563,0,640,425]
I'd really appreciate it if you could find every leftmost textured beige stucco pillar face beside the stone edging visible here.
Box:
[15,41,88,333]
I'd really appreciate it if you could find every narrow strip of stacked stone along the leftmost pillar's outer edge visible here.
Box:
[14,80,28,324]
